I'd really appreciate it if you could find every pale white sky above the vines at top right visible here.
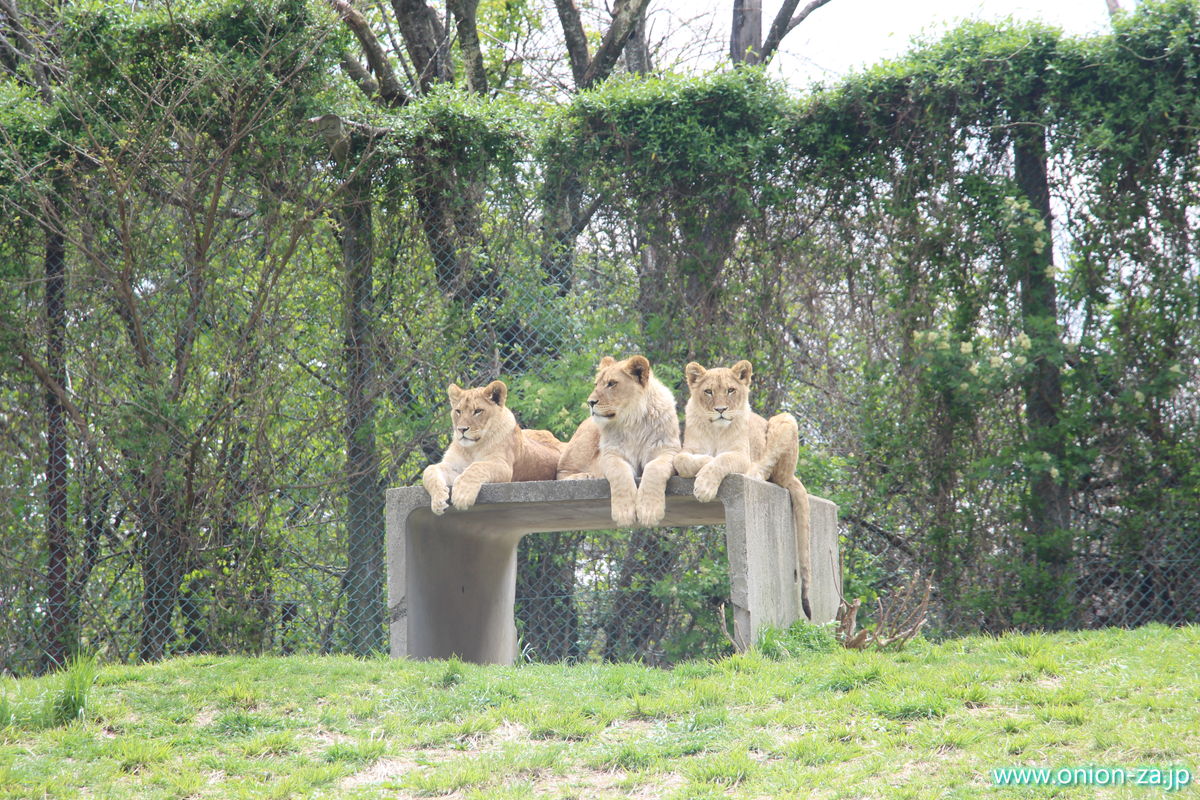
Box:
[650,0,1118,86]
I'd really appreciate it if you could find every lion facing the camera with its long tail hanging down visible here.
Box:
[674,361,812,619]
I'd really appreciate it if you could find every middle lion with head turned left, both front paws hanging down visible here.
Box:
[558,355,679,528]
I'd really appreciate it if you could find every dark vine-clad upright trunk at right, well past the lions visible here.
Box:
[1013,126,1073,627]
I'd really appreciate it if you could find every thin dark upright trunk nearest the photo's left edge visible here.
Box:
[42,221,71,669]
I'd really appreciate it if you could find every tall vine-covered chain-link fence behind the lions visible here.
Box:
[0,0,1200,672]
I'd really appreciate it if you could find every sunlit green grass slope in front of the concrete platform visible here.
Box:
[0,626,1200,800]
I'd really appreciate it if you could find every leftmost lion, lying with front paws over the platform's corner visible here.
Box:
[421,380,564,515]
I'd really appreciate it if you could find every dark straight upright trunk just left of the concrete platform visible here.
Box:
[340,164,384,655]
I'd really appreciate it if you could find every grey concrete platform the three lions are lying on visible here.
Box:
[386,475,841,663]
